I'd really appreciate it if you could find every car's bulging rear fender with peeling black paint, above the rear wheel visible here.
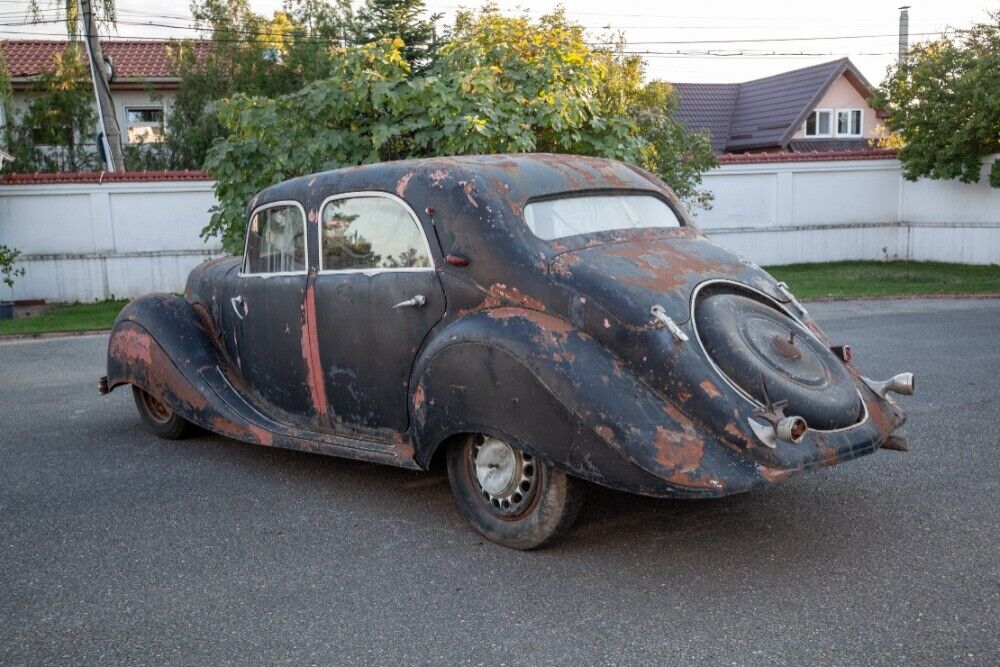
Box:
[410,308,787,497]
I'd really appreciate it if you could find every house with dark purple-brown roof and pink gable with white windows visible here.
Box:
[673,58,878,153]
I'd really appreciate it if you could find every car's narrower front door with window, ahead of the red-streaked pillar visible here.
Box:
[230,201,316,423]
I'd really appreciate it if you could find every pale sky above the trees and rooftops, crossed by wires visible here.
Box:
[0,0,1000,83]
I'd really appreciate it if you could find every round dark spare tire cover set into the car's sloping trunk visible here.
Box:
[695,292,862,430]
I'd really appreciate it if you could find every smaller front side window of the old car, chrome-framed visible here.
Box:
[243,204,306,273]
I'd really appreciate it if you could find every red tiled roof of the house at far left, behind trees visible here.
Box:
[0,39,209,79]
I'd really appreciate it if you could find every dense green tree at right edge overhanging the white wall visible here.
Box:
[869,13,1000,188]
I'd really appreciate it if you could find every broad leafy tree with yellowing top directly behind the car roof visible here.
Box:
[203,7,714,251]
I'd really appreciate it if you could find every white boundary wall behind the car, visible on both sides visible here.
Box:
[0,154,1000,301]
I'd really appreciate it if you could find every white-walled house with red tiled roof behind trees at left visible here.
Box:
[0,40,209,145]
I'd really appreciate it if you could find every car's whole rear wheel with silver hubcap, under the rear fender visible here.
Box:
[447,435,584,550]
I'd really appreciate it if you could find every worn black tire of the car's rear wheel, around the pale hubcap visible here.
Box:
[446,435,585,550]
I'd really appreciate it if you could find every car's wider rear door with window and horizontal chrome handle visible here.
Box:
[314,192,445,437]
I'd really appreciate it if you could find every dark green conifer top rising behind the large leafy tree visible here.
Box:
[352,0,441,73]
